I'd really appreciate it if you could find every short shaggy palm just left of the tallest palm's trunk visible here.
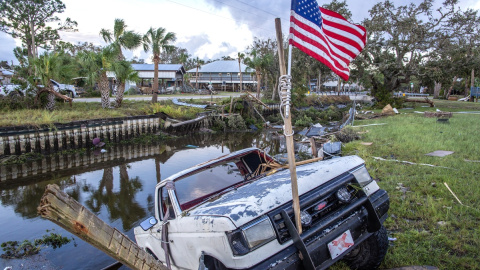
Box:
[79,46,117,109]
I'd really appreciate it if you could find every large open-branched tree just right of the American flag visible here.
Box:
[354,0,458,100]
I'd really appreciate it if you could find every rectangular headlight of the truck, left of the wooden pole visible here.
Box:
[227,217,275,255]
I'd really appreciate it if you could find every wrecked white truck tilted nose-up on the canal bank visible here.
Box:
[134,148,389,270]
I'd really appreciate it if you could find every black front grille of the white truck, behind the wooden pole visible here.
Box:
[269,173,365,244]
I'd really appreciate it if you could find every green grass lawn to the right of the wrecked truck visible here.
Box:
[338,107,480,269]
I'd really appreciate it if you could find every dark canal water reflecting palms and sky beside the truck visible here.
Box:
[0,133,284,269]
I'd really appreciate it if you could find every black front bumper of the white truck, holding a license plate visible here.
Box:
[249,189,389,270]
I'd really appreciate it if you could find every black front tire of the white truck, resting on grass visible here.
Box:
[343,225,388,270]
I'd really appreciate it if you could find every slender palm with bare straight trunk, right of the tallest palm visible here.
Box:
[143,27,176,103]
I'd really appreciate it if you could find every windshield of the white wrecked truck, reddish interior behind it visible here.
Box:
[175,162,244,210]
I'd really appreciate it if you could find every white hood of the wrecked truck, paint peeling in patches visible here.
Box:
[189,156,364,227]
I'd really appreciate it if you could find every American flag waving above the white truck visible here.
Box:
[289,0,367,81]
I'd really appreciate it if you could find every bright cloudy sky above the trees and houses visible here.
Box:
[0,0,480,63]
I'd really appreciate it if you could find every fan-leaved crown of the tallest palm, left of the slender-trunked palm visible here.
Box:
[100,19,142,104]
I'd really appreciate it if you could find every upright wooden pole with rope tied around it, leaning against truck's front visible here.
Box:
[275,18,302,234]
